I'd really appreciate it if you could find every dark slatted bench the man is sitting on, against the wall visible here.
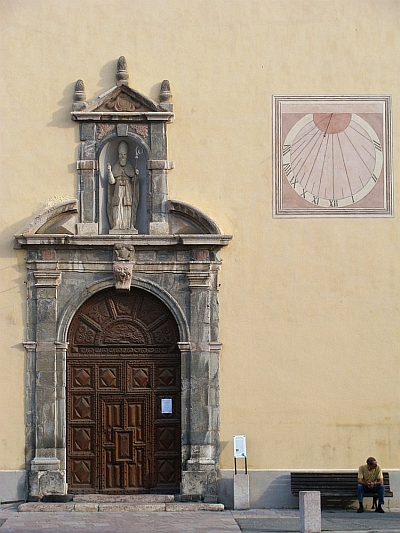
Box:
[290,472,393,508]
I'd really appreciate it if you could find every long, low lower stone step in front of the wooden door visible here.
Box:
[18,501,224,513]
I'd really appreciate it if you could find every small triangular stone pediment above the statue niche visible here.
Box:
[85,85,160,113]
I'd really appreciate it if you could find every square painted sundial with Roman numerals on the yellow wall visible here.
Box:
[273,95,393,218]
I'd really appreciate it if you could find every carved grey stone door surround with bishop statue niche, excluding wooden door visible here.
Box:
[16,57,231,501]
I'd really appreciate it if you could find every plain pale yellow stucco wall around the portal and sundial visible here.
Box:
[0,0,400,470]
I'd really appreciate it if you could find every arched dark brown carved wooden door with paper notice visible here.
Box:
[66,287,181,494]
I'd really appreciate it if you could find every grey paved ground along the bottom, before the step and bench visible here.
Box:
[0,508,400,533]
